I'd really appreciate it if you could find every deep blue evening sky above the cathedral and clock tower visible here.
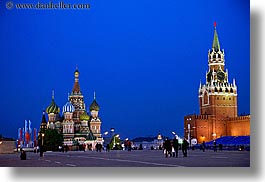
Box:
[0,0,250,138]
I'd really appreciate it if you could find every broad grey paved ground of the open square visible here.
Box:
[0,150,250,167]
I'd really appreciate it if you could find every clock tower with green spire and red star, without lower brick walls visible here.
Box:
[199,22,237,120]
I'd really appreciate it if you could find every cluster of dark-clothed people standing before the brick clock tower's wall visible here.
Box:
[163,137,189,158]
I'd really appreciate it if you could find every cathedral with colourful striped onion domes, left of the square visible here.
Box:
[39,68,103,148]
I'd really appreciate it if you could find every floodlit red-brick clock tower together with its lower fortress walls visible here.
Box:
[184,24,250,143]
